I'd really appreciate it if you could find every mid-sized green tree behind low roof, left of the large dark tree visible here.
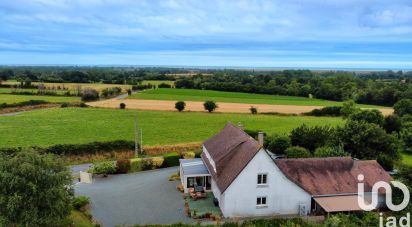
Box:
[290,124,334,152]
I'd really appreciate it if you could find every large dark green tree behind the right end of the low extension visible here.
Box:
[336,120,399,161]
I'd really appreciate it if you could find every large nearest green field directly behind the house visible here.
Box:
[0,108,343,147]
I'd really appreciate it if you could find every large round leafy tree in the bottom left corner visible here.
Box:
[0,150,73,226]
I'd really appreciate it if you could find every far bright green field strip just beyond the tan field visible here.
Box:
[129,88,384,107]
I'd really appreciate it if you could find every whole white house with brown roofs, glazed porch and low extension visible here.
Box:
[180,123,391,217]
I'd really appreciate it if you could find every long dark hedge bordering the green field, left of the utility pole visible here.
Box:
[42,140,135,155]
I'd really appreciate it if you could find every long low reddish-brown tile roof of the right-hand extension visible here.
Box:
[275,157,392,195]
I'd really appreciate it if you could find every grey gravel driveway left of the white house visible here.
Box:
[74,167,192,226]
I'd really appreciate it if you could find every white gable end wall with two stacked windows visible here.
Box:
[219,149,311,217]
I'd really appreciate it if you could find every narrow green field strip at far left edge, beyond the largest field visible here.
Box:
[0,94,80,104]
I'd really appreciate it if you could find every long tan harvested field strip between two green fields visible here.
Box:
[88,99,393,115]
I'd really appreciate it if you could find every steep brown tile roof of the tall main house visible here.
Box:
[202,123,261,193]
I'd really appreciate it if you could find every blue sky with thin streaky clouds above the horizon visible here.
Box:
[0,0,412,69]
